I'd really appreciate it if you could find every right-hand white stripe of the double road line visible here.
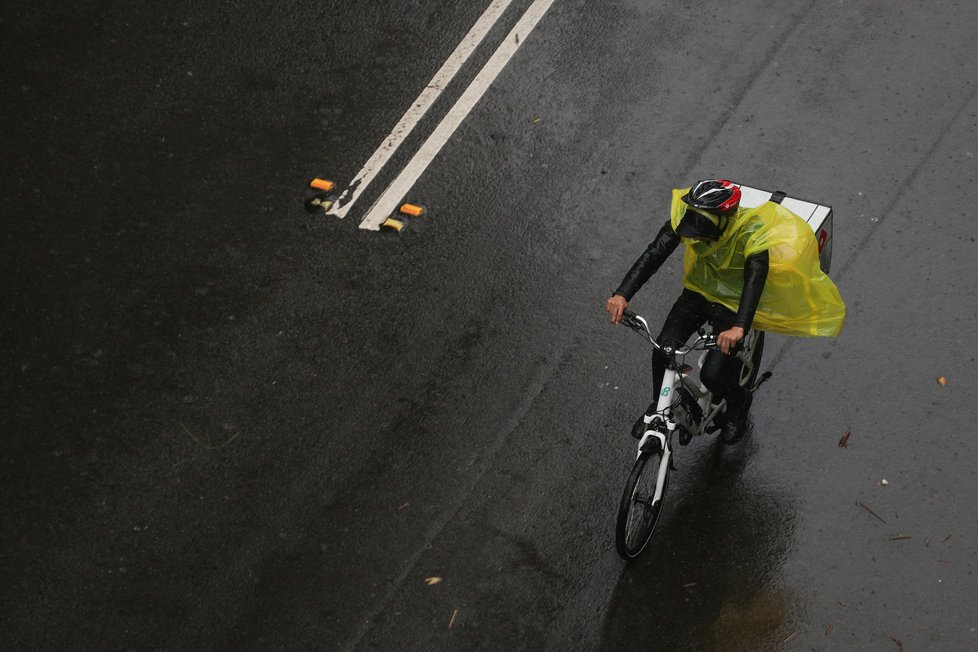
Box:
[360,0,554,231]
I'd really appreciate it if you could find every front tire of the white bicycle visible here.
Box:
[615,447,669,561]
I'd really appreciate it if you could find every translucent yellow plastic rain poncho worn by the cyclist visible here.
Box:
[672,188,846,337]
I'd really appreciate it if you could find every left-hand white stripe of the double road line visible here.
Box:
[326,0,513,218]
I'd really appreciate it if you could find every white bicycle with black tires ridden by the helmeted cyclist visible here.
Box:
[615,310,771,561]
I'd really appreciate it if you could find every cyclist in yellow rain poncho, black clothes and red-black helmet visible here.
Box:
[606,179,845,443]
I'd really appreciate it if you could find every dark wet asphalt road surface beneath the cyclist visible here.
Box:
[0,0,978,650]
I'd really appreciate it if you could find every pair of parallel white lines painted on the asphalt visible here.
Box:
[328,0,555,231]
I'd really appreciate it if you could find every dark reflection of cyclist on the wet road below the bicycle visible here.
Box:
[601,439,800,651]
